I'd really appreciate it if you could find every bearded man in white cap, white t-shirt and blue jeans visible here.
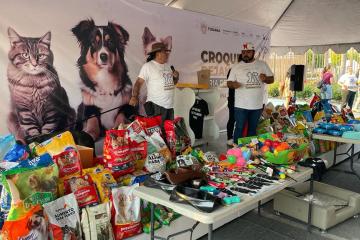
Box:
[227,42,274,142]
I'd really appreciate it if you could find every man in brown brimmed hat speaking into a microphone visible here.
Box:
[129,42,179,125]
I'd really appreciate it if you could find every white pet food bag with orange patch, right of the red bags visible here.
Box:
[145,132,171,173]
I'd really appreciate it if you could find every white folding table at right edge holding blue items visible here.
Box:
[312,134,360,179]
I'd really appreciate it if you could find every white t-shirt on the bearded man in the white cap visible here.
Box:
[228,60,273,110]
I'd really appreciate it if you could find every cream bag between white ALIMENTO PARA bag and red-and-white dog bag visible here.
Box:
[81,203,114,240]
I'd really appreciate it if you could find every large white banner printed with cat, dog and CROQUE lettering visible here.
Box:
[0,0,270,140]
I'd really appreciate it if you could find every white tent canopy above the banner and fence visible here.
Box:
[146,0,360,54]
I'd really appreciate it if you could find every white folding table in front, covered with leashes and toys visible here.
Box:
[134,166,313,240]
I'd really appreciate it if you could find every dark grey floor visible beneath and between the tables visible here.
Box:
[201,133,360,240]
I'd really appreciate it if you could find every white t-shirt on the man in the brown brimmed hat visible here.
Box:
[139,60,175,109]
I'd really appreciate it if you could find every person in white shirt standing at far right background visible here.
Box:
[338,66,358,109]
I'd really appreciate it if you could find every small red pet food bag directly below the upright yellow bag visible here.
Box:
[53,149,82,178]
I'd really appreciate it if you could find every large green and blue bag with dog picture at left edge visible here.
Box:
[2,154,59,208]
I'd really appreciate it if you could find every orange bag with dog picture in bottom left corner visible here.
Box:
[1,204,49,240]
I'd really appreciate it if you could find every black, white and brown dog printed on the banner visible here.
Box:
[72,19,132,140]
